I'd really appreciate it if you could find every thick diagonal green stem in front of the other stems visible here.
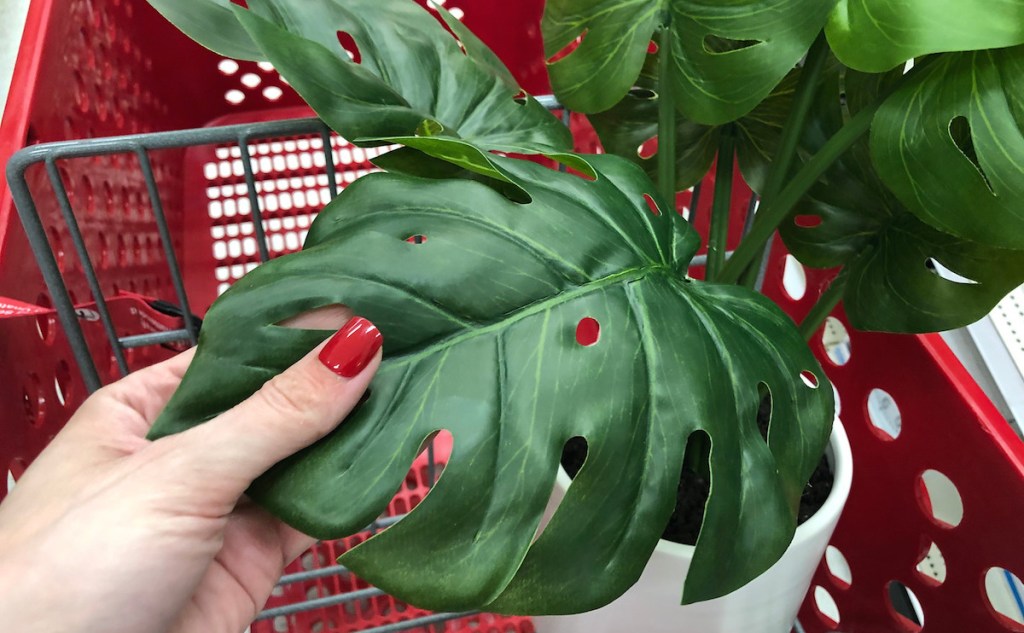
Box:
[719,99,883,284]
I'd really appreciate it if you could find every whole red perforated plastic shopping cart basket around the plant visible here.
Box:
[0,0,1024,633]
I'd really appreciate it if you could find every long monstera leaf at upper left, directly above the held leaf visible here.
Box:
[149,0,572,183]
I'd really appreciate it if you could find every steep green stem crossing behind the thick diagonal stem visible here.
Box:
[740,31,828,288]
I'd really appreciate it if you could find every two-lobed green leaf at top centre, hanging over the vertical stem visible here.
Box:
[543,0,835,125]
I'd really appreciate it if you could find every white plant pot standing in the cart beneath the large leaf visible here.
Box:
[535,420,853,633]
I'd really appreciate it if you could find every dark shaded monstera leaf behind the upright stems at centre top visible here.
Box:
[588,54,800,193]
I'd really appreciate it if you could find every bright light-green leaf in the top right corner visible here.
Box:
[825,0,1024,73]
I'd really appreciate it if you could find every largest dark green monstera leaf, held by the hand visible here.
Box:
[152,156,833,614]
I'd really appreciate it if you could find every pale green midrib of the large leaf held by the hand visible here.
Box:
[378,263,675,375]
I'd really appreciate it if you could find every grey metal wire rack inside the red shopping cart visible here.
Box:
[6,96,561,622]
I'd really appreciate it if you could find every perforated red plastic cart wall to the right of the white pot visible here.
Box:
[766,254,1024,633]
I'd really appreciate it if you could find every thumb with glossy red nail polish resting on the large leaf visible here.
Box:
[169,317,383,505]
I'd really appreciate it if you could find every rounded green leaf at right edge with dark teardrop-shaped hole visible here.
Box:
[871,46,1024,250]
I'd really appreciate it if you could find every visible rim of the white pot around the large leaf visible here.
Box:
[558,417,853,558]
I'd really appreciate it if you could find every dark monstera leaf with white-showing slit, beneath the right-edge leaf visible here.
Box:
[780,66,1024,333]
